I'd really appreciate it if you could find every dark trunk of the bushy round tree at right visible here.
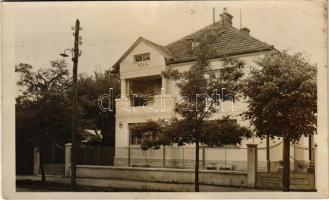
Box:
[282,137,290,192]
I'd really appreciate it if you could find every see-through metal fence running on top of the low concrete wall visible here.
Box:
[74,142,309,172]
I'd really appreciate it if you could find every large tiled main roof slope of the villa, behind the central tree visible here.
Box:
[166,21,273,64]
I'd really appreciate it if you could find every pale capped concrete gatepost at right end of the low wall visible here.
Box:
[247,144,257,187]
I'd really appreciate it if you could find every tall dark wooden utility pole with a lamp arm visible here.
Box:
[71,19,80,191]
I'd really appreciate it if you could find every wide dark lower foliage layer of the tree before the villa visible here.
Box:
[131,116,251,150]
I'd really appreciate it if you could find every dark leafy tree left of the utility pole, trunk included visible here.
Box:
[15,60,71,183]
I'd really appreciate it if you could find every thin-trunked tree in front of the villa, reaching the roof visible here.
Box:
[132,26,250,192]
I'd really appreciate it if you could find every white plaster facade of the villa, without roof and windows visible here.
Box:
[116,51,270,147]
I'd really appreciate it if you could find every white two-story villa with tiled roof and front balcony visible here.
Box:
[113,10,308,170]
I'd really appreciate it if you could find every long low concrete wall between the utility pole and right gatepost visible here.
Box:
[77,165,247,187]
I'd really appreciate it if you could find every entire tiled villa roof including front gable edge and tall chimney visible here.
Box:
[112,12,274,72]
